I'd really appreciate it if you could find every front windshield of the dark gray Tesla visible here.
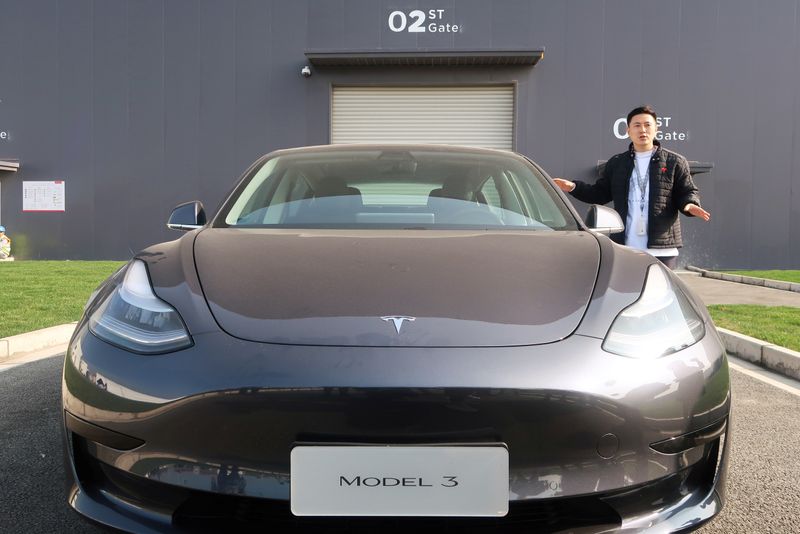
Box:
[215,148,578,230]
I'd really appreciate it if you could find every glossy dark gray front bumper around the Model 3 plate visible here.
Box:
[63,327,730,532]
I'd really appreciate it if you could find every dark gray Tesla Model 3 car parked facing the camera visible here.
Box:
[63,145,731,532]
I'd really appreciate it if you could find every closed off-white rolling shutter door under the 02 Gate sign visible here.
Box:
[331,85,514,150]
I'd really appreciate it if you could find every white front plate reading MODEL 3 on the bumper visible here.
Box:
[291,445,508,517]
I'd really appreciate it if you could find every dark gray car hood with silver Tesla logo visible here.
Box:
[195,228,600,347]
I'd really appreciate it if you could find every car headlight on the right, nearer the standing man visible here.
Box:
[603,264,705,359]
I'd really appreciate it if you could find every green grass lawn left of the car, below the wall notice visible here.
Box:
[0,261,125,338]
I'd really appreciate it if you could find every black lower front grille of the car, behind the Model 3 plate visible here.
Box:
[72,434,721,533]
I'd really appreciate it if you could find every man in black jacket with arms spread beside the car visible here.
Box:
[554,106,711,269]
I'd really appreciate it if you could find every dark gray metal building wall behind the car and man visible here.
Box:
[0,0,800,268]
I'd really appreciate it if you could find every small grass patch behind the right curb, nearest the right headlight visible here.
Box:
[708,304,800,351]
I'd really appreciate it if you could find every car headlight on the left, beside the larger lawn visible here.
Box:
[89,260,192,354]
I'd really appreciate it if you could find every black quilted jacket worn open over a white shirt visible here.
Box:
[570,141,700,248]
